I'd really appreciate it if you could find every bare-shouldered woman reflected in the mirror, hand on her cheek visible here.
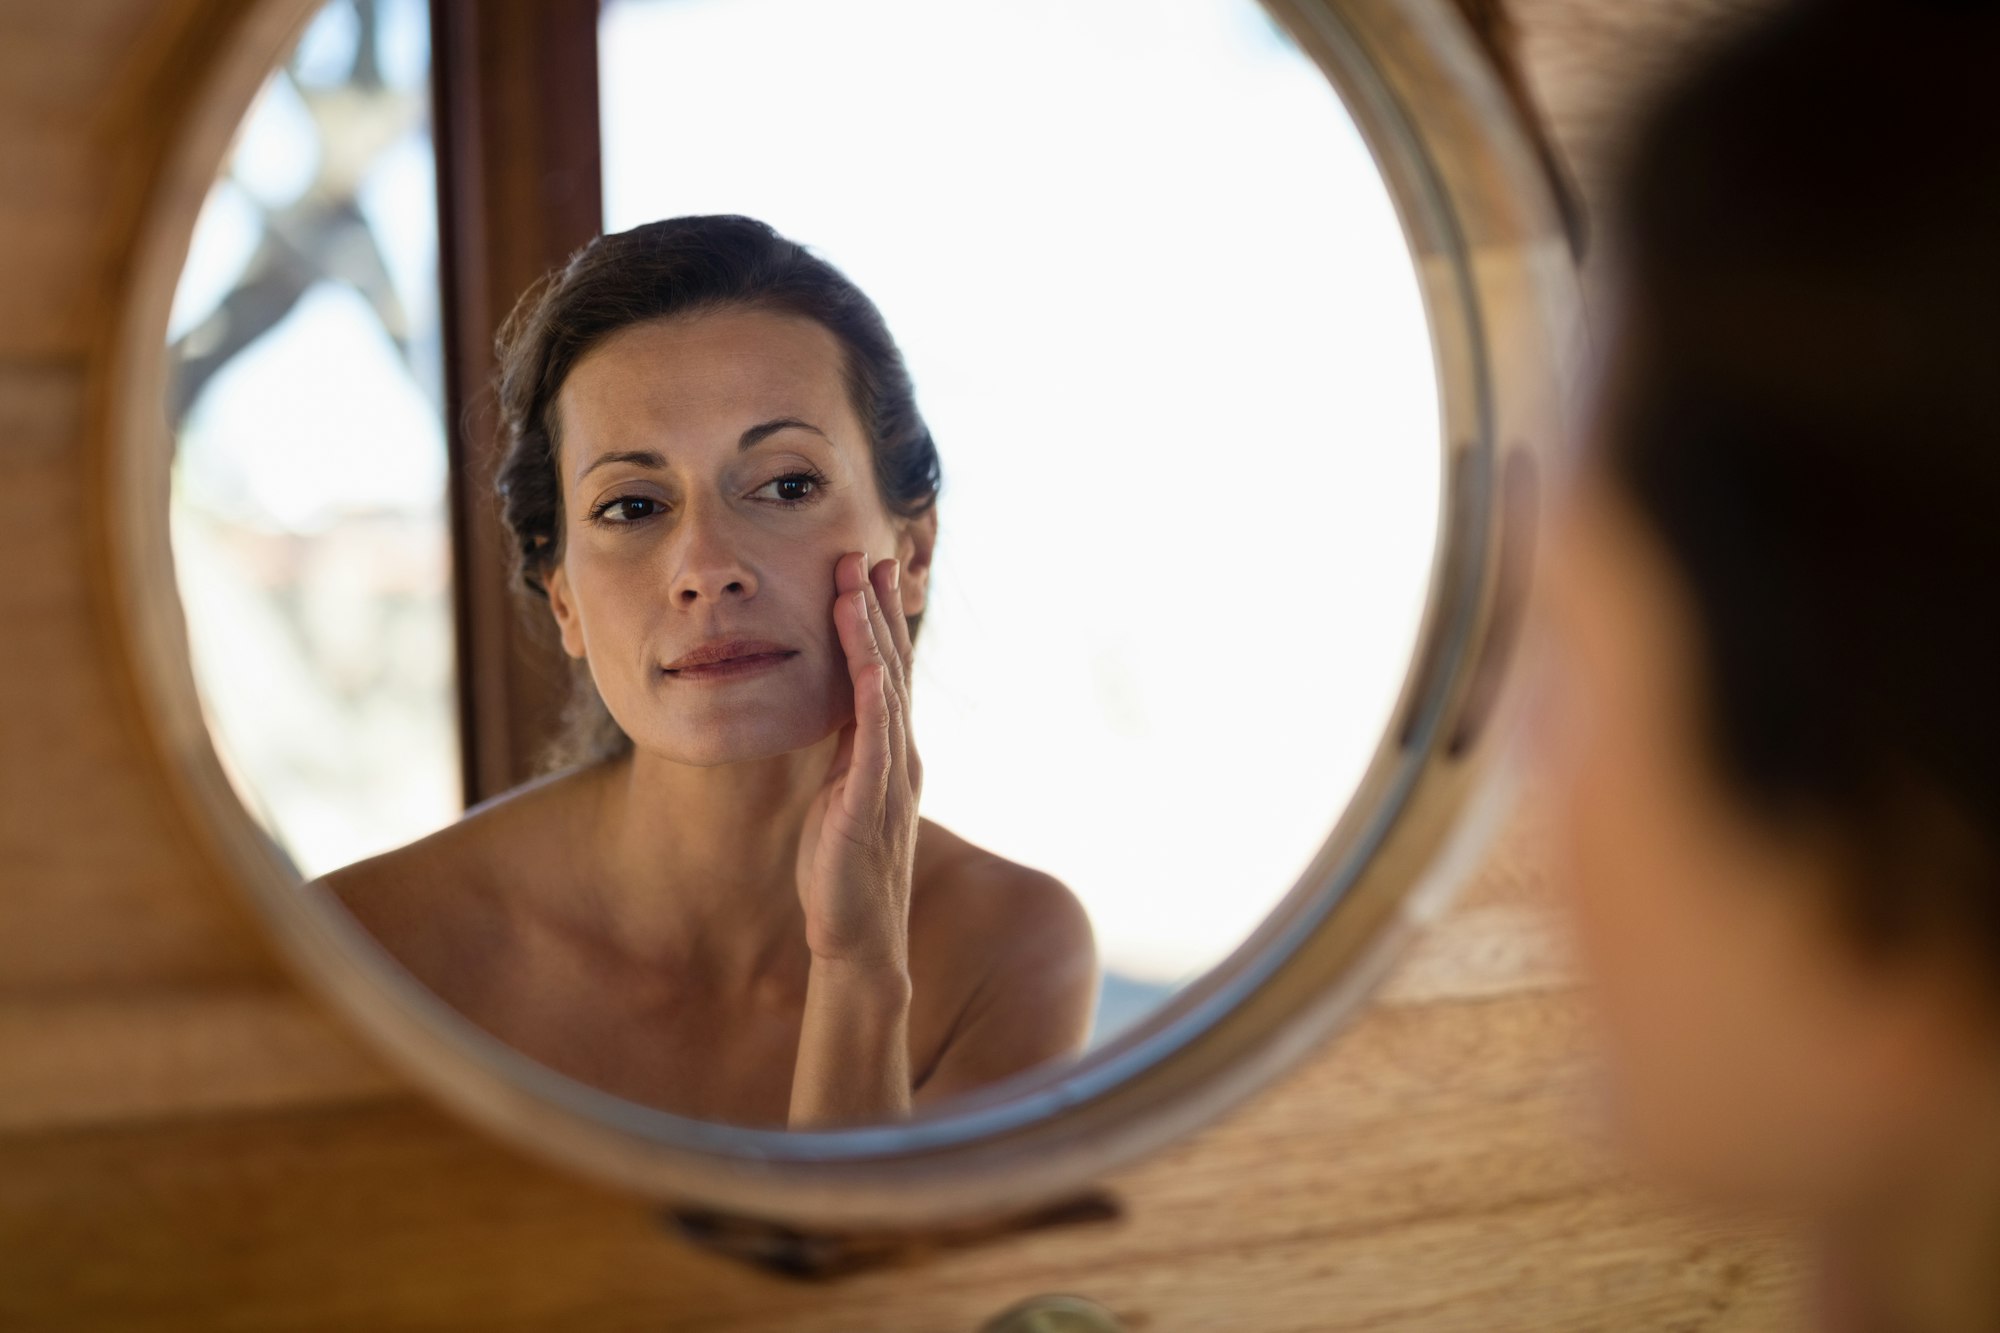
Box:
[312,216,1098,1127]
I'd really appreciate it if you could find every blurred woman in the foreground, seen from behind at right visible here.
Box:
[1544,0,2000,1331]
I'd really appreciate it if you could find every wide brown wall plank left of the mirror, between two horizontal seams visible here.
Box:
[0,358,274,991]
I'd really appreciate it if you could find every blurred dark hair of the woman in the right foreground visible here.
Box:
[1604,0,2000,956]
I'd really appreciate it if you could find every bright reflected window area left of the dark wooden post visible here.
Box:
[168,0,462,877]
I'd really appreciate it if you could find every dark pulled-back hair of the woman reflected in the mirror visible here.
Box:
[496,214,940,771]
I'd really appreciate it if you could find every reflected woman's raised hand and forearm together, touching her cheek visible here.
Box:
[790,552,924,1127]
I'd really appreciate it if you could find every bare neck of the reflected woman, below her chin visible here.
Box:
[548,737,836,985]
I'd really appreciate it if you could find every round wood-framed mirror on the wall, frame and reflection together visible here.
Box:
[112,0,1572,1223]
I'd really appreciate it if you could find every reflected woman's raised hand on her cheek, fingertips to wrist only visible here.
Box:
[798,552,924,973]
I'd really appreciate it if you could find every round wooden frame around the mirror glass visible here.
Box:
[105,0,1582,1229]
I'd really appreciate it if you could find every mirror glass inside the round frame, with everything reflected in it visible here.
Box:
[170,0,1440,1127]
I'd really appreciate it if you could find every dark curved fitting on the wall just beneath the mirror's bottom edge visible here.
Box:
[662,1191,1124,1281]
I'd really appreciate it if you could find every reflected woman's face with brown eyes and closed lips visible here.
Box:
[548,308,934,765]
